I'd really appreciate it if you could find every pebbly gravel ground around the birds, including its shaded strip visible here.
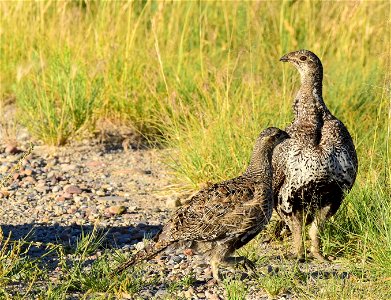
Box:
[0,118,350,300]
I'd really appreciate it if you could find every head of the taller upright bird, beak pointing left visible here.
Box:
[280,49,323,78]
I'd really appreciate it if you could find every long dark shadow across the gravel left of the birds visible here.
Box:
[0,223,161,270]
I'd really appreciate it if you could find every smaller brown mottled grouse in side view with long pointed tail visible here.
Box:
[113,127,288,280]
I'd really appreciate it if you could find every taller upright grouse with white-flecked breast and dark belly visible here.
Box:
[273,50,358,261]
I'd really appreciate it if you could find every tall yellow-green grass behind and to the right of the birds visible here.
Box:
[0,0,391,299]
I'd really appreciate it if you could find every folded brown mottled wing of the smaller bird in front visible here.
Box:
[168,180,262,241]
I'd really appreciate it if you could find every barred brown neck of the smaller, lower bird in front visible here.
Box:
[244,143,273,183]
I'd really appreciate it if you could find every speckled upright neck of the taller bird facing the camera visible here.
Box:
[293,69,329,119]
